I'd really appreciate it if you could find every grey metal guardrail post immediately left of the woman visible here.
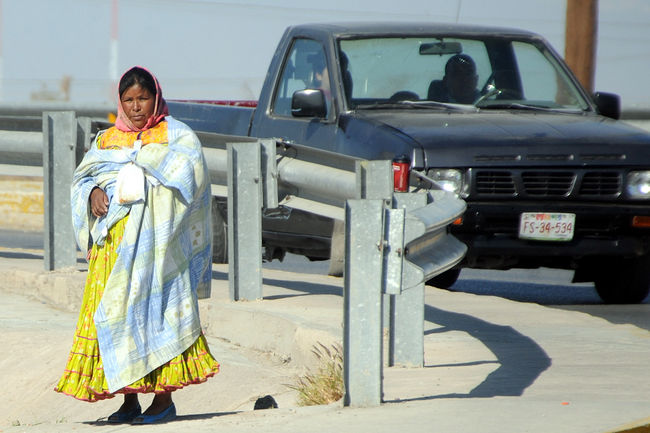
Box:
[43,111,77,271]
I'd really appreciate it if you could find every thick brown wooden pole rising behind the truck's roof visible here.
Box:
[564,0,598,93]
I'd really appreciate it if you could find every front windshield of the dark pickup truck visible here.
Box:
[339,37,590,111]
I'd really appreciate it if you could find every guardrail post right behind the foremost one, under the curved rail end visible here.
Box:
[388,193,427,367]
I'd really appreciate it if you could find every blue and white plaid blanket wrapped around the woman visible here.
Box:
[71,117,212,392]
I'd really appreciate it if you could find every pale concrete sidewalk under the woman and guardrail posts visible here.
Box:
[0,249,650,433]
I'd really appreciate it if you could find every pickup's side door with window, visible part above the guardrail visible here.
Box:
[252,38,336,150]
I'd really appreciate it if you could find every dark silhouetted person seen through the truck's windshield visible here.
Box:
[428,54,480,104]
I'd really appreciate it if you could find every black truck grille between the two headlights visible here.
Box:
[474,169,623,198]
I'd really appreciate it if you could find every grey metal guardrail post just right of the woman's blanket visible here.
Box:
[227,141,262,301]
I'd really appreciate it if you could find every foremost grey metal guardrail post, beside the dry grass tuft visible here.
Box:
[343,200,385,406]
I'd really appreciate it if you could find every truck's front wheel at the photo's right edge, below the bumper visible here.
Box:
[594,256,650,304]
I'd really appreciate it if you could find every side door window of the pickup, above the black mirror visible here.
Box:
[271,39,332,117]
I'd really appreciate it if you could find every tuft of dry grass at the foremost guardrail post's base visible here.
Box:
[288,343,343,406]
